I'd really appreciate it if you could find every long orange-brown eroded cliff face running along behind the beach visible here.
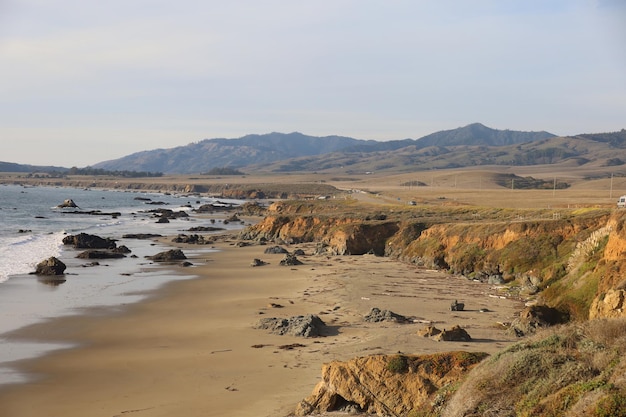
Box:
[241,204,626,319]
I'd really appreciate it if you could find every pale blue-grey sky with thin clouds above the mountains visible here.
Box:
[0,0,626,167]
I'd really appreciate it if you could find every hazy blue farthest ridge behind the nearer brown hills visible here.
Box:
[94,123,554,174]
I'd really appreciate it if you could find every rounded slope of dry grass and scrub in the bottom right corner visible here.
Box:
[442,319,626,417]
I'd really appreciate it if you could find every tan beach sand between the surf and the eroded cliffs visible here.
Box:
[0,235,522,417]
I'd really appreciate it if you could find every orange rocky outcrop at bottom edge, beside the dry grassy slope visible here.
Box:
[295,352,487,416]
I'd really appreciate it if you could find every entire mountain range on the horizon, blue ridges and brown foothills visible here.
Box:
[0,123,626,174]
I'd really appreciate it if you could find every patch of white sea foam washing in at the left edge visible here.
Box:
[0,232,64,282]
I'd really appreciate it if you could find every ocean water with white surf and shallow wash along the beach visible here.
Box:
[0,185,243,384]
